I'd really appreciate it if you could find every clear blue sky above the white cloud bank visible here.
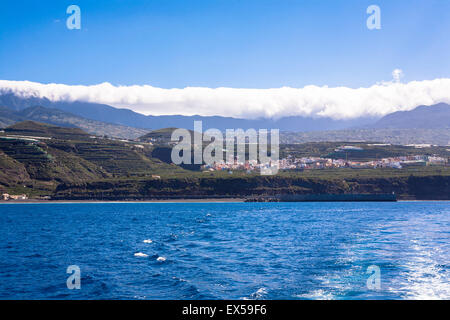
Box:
[0,0,450,88]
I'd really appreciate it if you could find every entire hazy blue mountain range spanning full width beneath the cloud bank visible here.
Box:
[0,91,450,143]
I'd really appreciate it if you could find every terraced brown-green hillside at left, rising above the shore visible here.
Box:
[0,121,183,194]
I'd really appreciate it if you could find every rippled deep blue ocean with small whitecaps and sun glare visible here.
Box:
[0,202,450,299]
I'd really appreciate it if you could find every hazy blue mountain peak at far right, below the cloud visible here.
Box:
[372,103,450,129]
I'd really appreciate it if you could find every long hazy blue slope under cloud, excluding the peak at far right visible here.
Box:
[0,92,377,132]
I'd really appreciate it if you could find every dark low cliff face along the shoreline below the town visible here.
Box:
[53,176,450,200]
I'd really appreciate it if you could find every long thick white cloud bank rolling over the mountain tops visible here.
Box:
[0,79,450,119]
